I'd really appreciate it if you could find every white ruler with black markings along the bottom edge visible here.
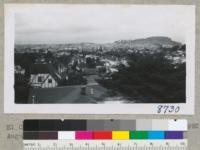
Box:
[23,139,187,150]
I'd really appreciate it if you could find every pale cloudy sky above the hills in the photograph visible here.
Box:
[15,4,190,44]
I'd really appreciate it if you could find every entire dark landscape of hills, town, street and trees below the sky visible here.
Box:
[14,37,186,104]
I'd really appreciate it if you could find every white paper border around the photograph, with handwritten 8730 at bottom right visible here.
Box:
[4,4,195,115]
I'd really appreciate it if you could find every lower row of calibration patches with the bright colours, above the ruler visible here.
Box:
[24,131,184,140]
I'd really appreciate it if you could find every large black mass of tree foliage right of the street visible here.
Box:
[100,52,186,103]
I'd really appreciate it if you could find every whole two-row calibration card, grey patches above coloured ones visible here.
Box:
[24,120,187,140]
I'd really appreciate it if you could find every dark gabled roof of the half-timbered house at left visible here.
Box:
[30,64,62,82]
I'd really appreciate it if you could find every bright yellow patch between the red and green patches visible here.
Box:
[112,131,129,140]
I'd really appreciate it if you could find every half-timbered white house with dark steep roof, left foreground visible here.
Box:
[29,64,62,88]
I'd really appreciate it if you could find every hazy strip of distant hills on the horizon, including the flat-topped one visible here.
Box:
[15,36,182,51]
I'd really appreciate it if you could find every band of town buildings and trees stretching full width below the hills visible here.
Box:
[15,41,185,88]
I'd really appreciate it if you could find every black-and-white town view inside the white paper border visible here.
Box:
[4,4,194,112]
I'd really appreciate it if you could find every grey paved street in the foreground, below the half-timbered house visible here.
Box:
[29,75,108,103]
